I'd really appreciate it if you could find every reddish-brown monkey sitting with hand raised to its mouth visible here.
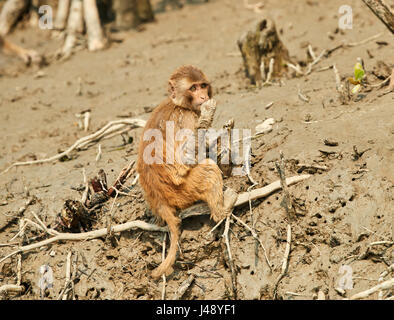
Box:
[137,66,236,278]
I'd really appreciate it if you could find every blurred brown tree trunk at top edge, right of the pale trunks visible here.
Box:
[113,0,154,30]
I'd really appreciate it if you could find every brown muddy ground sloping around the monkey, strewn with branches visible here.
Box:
[0,0,394,300]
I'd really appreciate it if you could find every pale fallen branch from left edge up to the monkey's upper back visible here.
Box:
[0,119,146,175]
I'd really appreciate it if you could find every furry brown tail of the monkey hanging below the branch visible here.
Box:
[152,206,181,279]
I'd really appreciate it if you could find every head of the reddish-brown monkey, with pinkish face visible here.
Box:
[169,65,212,112]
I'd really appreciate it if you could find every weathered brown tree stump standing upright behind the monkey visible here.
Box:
[238,18,291,84]
